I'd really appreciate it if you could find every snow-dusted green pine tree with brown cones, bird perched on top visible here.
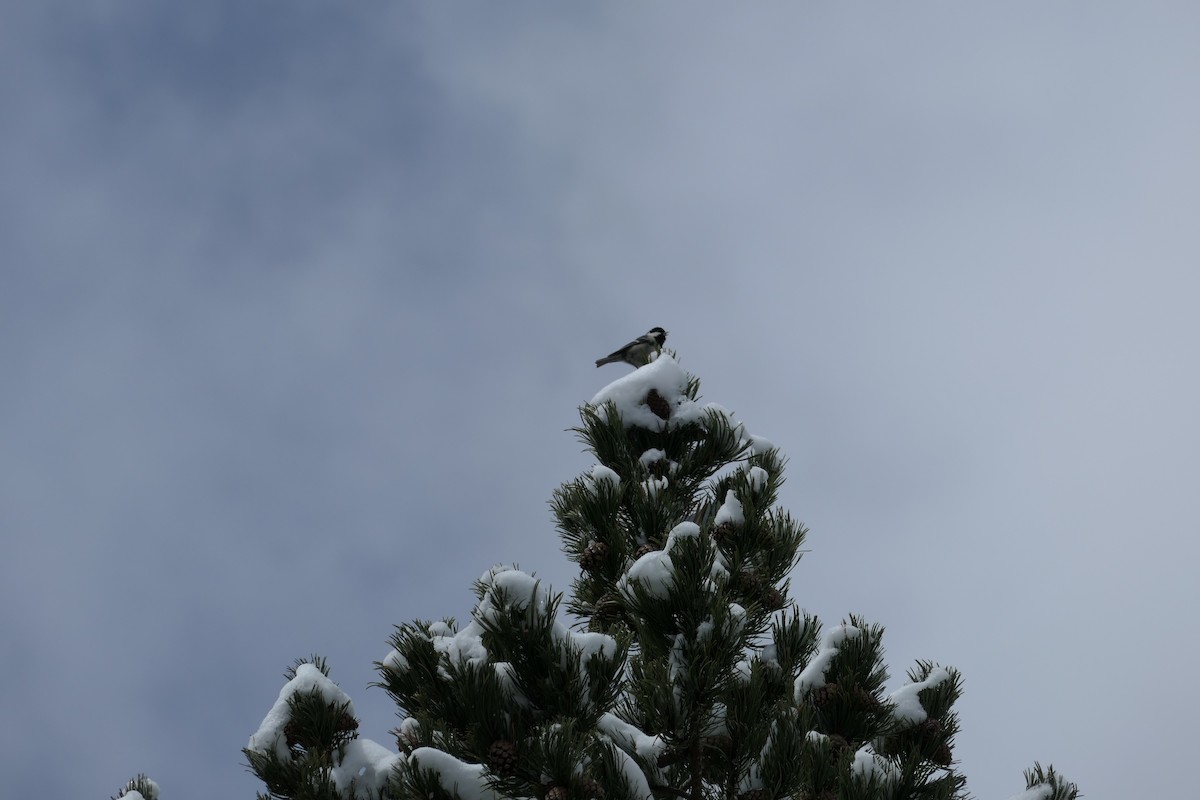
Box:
[136,354,1078,800]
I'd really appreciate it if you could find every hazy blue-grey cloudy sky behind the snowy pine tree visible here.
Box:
[0,0,1200,800]
